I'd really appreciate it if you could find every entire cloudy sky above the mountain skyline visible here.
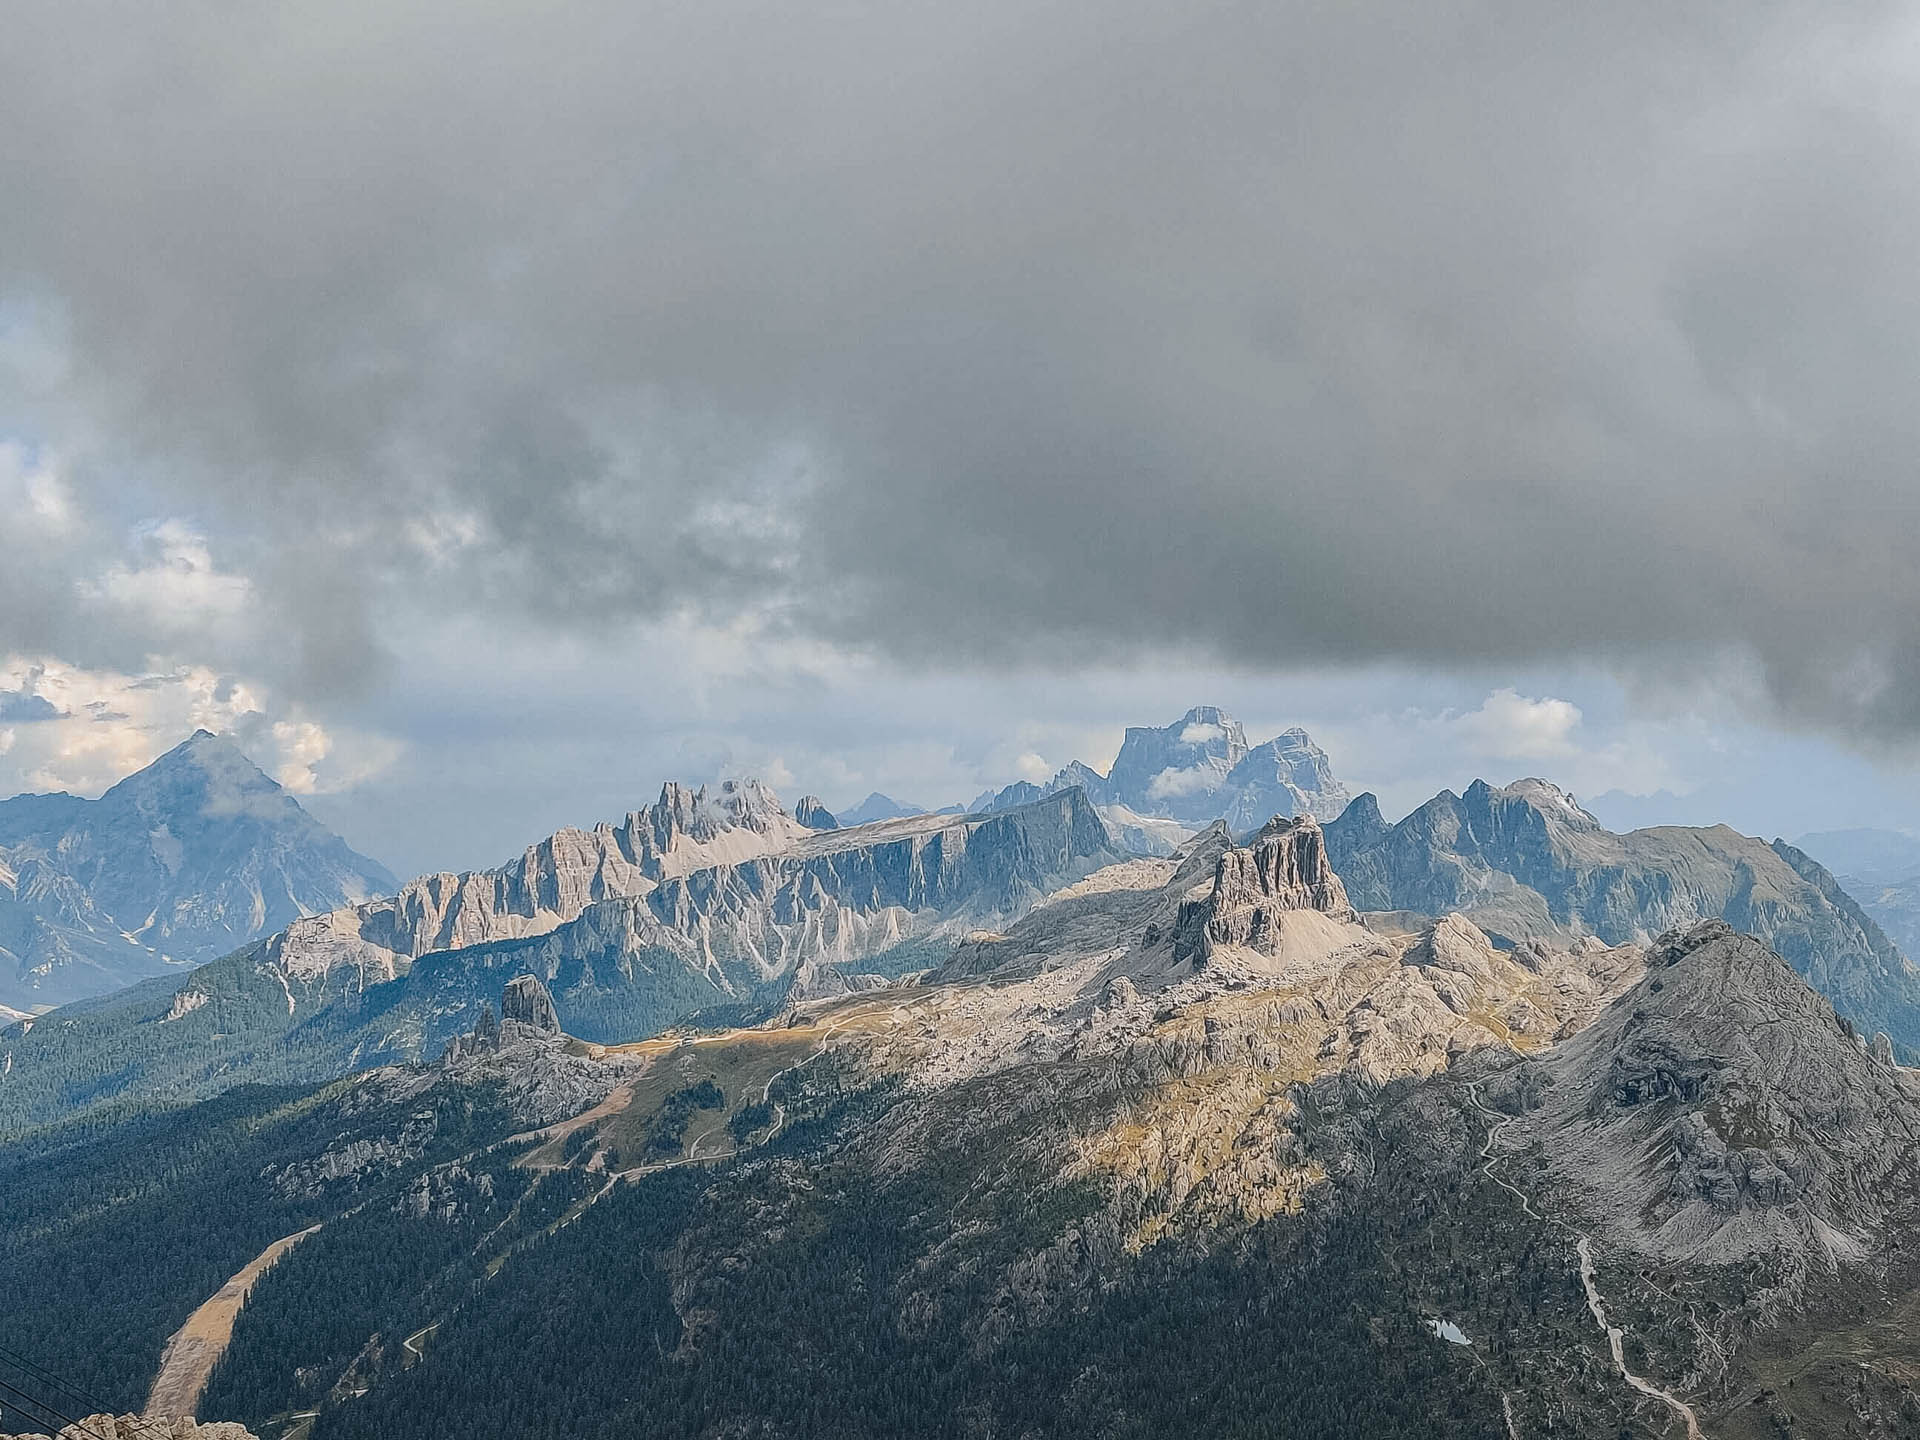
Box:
[0,0,1920,874]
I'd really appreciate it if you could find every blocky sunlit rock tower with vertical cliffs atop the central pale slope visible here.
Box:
[1173,816,1359,964]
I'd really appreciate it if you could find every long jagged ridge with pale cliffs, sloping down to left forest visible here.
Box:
[0,783,1117,1133]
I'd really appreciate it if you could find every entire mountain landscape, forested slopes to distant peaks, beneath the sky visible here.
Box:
[18,708,1920,1440]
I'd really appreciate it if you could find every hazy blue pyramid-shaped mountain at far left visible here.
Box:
[0,730,394,1010]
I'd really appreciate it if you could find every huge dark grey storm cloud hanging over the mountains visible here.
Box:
[0,0,1920,733]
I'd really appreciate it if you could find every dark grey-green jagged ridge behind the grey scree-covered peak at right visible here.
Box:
[1327,780,1920,1046]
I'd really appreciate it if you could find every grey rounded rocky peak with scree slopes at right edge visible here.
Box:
[1538,920,1920,1263]
